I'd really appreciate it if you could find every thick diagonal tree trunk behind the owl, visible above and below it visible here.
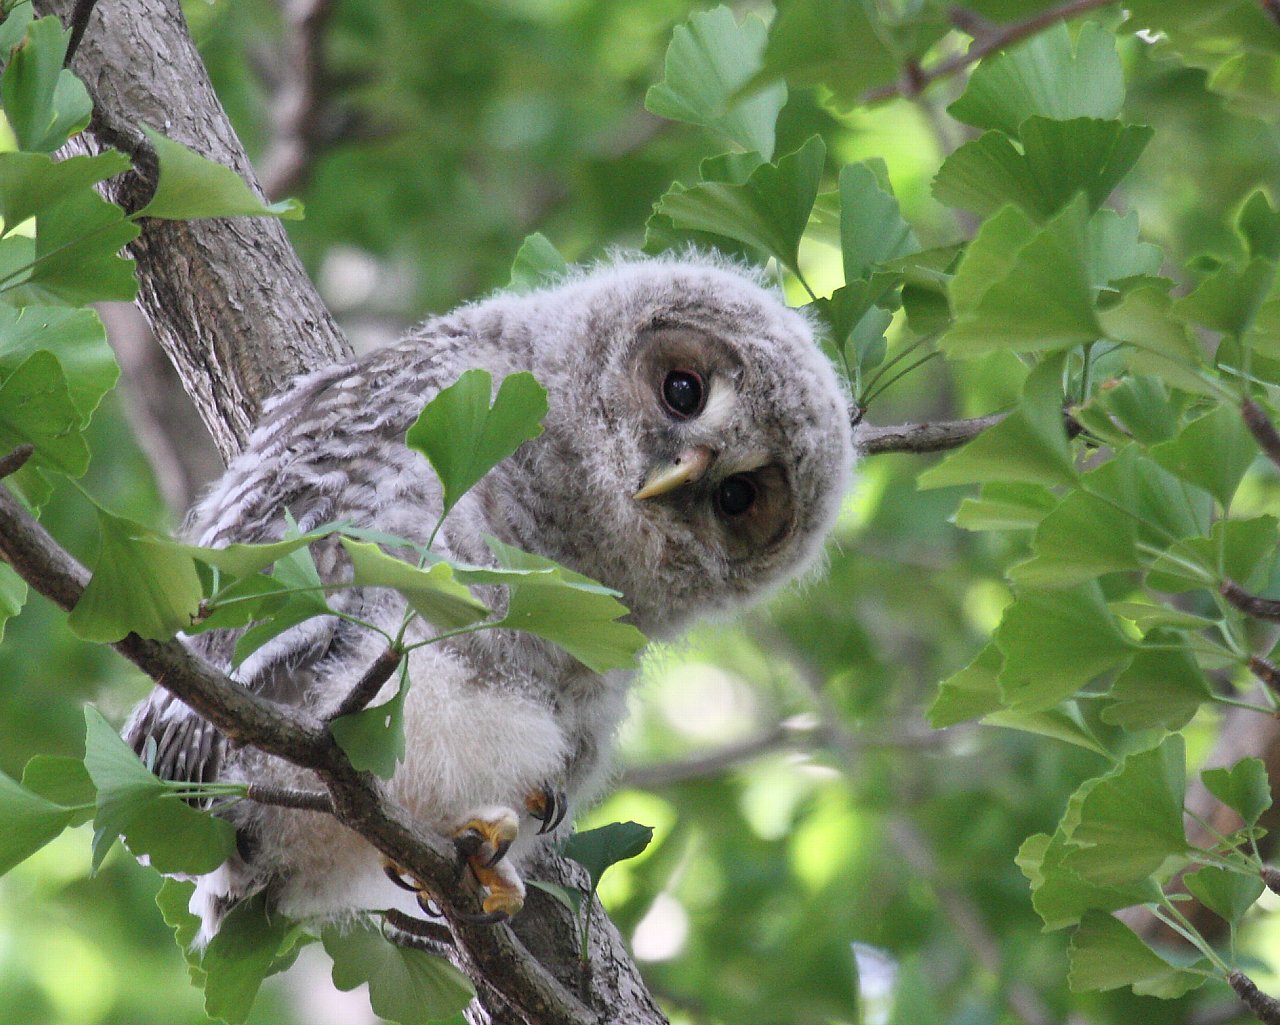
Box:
[36,0,666,1025]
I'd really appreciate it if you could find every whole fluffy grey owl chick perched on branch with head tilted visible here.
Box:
[127,252,852,939]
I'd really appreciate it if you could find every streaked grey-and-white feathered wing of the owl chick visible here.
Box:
[124,342,449,782]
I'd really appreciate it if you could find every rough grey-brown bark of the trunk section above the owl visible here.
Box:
[36,0,351,459]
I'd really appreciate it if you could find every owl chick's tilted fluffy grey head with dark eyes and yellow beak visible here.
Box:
[483,257,854,636]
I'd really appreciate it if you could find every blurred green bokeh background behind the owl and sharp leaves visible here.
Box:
[0,0,1280,1025]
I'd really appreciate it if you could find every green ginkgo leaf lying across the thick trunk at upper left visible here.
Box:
[133,125,302,220]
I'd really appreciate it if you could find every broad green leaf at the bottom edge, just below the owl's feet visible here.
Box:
[321,921,475,1025]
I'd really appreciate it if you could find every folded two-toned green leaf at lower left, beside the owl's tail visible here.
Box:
[84,705,236,875]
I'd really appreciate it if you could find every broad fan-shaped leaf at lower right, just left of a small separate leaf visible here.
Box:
[1066,733,1188,887]
